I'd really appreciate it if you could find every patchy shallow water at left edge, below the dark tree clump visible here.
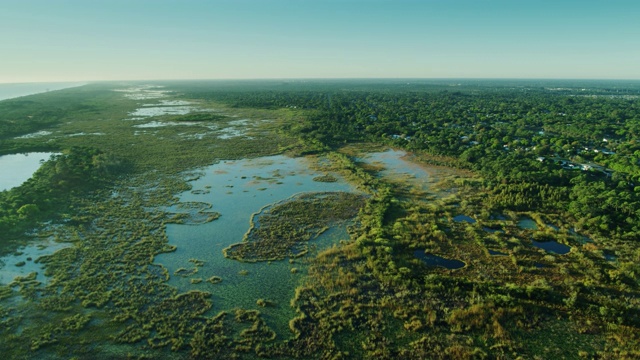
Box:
[0,239,70,285]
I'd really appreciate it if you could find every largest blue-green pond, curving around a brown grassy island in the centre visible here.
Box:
[155,155,356,334]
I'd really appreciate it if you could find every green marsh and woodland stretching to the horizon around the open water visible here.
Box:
[0,80,640,359]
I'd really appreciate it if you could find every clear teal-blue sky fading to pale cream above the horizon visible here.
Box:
[0,0,640,83]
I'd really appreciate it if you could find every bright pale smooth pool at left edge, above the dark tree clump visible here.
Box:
[0,152,54,191]
